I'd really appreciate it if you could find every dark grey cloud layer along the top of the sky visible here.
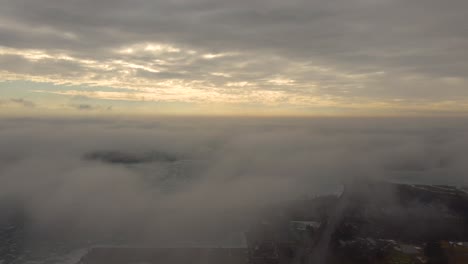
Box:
[2,0,467,67]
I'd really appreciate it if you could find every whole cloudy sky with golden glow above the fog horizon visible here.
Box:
[0,0,468,116]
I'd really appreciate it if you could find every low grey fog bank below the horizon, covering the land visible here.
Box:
[0,117,468,248]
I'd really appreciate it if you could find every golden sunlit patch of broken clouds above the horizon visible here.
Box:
[0,43,388,113]
